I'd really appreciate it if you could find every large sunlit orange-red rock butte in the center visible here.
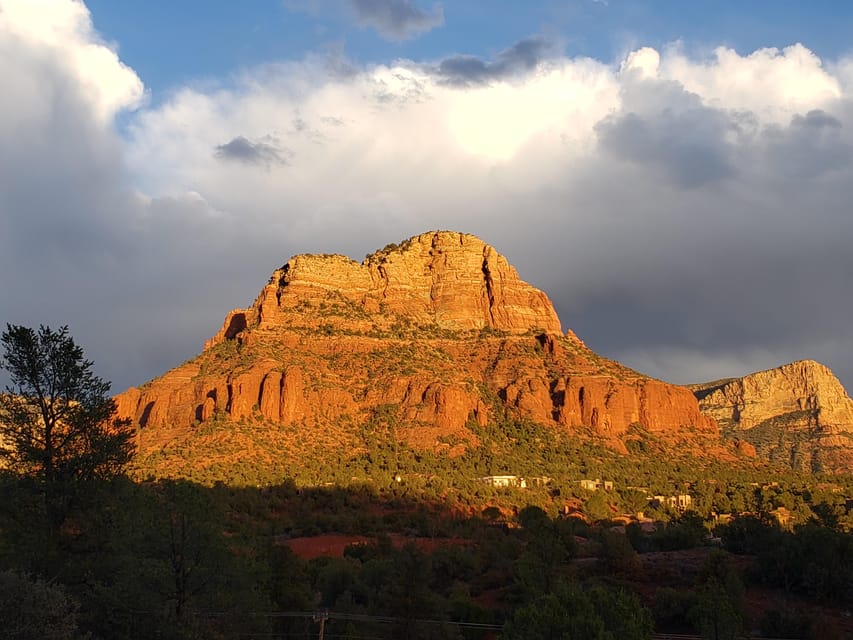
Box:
[117,231,719,482]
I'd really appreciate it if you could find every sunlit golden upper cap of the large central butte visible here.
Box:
[206,231,561,348]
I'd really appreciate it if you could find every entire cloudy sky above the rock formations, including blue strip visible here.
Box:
[0,0,853,391]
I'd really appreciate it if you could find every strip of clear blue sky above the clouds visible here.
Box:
[87,0,853,101]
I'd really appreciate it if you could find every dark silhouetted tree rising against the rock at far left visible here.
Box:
[0,325,133,524]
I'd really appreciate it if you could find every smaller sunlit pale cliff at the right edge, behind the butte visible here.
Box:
[691,360,853,472]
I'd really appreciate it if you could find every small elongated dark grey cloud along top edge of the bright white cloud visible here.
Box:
[436,36,555,86]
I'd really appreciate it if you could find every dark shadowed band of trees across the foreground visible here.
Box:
[0,474,853,639]
